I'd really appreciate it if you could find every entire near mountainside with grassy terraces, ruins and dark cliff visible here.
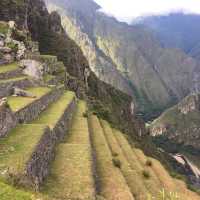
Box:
[0,0,200,200]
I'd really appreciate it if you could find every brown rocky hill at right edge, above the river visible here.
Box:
[150,94,200,149]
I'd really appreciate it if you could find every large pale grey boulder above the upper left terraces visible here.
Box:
[20,60,44,80]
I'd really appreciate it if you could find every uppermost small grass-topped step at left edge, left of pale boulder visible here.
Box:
[0,62,23,80]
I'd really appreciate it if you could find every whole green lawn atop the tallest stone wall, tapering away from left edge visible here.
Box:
[0,92,74,184]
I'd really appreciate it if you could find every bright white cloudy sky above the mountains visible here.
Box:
[94,0,200,22]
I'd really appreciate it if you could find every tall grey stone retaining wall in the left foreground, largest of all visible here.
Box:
[20,98,76,190]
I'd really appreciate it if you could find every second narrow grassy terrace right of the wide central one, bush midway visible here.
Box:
[101,121,149,200]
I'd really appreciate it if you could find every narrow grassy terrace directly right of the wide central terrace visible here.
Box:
[89,116,134,200]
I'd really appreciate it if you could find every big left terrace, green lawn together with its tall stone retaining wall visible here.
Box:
[0,92,75,189]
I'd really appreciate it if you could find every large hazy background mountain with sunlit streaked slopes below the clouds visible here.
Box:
[46,0,199,119]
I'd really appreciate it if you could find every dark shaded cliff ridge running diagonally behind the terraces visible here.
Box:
[0,0,144,132]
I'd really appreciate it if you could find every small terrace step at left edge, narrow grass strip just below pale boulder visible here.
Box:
[0,76,34,98]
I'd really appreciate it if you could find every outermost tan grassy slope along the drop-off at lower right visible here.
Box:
[112,127,200,200]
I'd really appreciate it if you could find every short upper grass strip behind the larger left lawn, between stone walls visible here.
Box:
[33,92,75,128]
